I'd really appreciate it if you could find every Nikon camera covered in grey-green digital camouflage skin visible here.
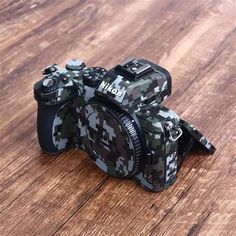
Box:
[34,58,215,192]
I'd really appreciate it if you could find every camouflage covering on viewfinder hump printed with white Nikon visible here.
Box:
[97,59,168,111]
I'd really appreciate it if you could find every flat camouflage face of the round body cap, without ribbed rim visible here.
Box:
[80,103,137,177]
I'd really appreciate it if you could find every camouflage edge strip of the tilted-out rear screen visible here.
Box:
[180,119,216,154]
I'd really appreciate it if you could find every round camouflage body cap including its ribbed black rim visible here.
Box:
[84,102,143,178]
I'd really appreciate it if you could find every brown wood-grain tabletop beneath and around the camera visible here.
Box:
[0,0,236,236]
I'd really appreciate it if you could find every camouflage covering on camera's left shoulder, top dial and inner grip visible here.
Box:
[34,60,98,151]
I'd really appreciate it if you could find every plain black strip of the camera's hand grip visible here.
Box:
[37,101,62,154]
